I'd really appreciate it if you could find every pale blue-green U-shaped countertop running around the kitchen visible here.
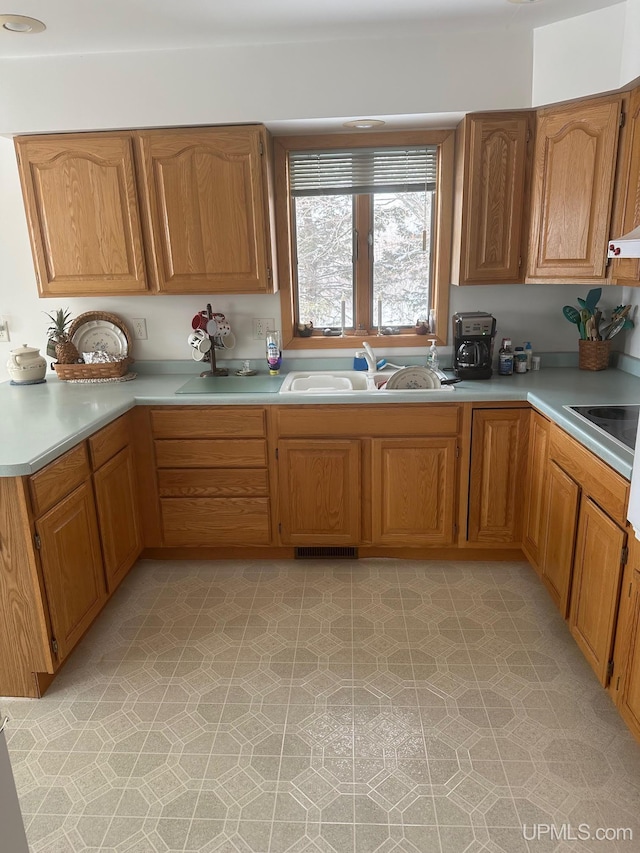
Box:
[0,367,640,479]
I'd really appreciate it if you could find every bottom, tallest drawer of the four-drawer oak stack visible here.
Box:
[160,498,271,548]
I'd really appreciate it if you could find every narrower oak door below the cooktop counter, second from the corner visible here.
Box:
[541,462,580,618]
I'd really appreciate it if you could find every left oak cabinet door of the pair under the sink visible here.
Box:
[278,439,361,545]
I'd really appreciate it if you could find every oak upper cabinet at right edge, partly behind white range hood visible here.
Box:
[609,86,640,284]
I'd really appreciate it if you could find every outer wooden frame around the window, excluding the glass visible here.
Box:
[273,129,455,350]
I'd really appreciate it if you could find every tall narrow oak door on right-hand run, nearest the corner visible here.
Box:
[522,412,549,573]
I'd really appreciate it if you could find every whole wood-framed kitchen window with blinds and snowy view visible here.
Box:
[275,131,453,349]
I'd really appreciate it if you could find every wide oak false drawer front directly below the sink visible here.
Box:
[276,403,460,438]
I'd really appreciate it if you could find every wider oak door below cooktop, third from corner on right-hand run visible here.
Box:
[569,492,626,685]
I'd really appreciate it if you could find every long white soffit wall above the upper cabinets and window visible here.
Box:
[0,30,532,134]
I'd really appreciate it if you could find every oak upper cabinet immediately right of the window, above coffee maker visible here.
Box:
[452,113,532,284]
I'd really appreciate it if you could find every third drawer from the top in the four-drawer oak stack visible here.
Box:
[158,468,269,498]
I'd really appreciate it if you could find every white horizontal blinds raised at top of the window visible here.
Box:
[289,145,438,196]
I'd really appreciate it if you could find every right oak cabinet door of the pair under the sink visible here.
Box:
[372,438,456,547]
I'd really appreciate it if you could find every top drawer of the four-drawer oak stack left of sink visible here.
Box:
[151,406,266,438]
